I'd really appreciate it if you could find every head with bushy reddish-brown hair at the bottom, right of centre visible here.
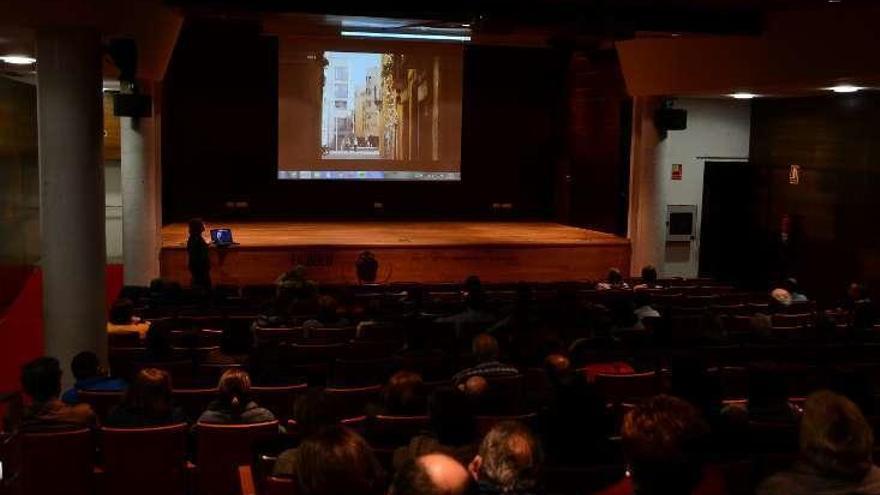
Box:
[621,395,709,495]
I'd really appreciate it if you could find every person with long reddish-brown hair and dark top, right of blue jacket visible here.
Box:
[105,368,186,428]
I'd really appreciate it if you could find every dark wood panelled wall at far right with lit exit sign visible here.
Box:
[751,93,880,300]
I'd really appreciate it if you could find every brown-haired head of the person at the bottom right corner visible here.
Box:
[800,390,874,479]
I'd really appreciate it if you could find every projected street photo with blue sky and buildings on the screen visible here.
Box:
[321,51,440,160]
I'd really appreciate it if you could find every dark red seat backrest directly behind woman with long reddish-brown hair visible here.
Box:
[100,424,189,495]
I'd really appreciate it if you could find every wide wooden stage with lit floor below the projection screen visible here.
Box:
[160,221,630,285]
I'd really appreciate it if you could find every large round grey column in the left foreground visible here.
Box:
[37,29,107,384]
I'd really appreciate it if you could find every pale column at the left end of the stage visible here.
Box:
[119,108,159,285]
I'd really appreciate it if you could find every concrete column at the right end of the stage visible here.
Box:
[629,97,666,276]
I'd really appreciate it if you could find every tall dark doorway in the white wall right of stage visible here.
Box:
[700,162,763,287]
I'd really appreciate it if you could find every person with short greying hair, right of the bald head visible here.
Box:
[468,421,543,494]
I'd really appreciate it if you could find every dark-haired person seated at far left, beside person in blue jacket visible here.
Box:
[20,357,97,431]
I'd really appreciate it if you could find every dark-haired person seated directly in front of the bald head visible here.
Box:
[394,387,479,468]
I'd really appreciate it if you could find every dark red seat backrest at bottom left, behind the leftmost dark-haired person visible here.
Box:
[21,429,95,495]
